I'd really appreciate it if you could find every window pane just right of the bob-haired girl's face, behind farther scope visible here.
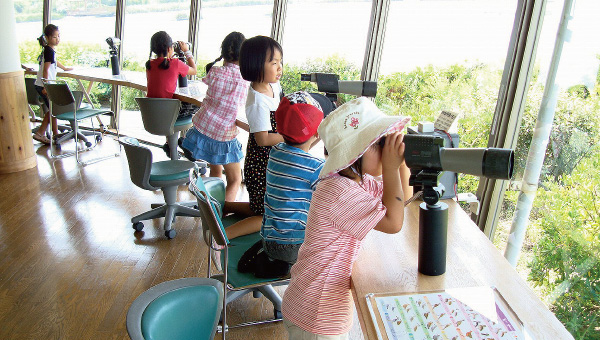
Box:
[282,0,372,92]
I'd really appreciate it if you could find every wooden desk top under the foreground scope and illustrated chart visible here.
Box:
[352,200,573,339]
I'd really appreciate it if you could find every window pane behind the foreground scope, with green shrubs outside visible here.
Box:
[377,0,517,198]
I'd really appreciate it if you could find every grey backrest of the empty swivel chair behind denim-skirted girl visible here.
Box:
[119,137,160,191]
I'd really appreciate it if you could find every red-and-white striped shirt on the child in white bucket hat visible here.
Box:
[282,174,386,335]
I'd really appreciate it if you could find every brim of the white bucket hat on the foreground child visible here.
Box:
[319,116,410,178]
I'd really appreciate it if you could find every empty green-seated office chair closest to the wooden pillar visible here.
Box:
[44,81,121,165]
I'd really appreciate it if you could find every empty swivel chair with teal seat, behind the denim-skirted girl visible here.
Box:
[119,137,200,239]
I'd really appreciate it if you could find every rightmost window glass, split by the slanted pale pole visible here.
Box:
[494,0,600,339]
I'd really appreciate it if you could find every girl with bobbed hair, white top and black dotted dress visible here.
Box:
[240,36,283,216]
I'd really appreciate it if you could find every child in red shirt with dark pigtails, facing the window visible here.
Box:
[146,31,197,157]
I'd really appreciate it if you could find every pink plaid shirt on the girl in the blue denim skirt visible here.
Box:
[192,63,250,142]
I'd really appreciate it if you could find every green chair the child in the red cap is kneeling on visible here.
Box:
[189,170,289,339]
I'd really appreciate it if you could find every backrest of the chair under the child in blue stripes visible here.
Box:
[189,169,229,247]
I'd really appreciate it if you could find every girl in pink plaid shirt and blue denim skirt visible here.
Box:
[181,32,249,201]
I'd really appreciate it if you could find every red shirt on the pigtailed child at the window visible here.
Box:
[146,58,190,98]
